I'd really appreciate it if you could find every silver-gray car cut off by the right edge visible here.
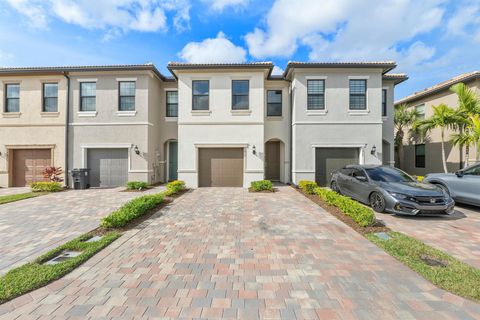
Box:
[424,162,480,206]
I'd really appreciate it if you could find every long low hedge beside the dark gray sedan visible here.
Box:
[314,187,375,227]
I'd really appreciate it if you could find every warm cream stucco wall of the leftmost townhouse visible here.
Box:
[0,74,67,187]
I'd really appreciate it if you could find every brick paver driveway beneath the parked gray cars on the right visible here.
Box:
[377,206,480,268]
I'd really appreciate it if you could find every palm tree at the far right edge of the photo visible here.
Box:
[450,82,480,166]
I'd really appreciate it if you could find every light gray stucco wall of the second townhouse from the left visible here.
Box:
[69,71,160,183]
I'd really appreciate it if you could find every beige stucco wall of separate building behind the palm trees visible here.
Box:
[402,80,480,175]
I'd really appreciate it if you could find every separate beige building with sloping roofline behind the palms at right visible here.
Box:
[395,71,480,176]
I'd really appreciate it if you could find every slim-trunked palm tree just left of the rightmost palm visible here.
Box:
[413,103,458,173]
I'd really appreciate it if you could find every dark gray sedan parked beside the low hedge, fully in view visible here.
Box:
[330,165,455,215]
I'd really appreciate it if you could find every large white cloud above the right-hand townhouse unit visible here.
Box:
[245,0,444,65]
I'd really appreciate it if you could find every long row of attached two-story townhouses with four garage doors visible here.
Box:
[0,61,407,188]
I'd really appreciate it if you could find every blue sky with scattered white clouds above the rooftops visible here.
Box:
[0,0,480,99]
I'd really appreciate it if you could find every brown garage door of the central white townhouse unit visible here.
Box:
[198,148,243,187]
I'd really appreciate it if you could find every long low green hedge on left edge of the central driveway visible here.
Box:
[102,193,164,228]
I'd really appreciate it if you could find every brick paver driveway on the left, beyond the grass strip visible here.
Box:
[0,187,160,274]
